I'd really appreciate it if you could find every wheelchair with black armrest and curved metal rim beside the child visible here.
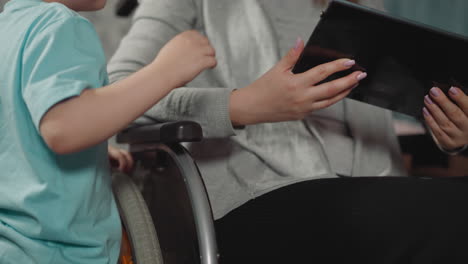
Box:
[113,121,218,264]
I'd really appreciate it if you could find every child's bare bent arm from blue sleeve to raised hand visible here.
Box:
[40,31,216,154]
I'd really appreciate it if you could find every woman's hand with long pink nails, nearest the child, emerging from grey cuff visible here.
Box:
[230,39,366,125]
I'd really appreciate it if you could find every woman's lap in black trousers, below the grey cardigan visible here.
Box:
[215,177,468,263]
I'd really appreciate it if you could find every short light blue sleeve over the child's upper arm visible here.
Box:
[22,16,108,132]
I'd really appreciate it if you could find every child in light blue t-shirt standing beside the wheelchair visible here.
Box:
[0,0,216,264]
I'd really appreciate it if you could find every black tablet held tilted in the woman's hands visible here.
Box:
[293,0,468,118]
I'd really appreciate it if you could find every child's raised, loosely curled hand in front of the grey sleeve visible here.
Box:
[153,30,217,87]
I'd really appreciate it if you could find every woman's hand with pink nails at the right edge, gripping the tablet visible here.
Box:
[423,87,468,151]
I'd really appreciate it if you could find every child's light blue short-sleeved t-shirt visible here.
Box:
[0,0,121,264]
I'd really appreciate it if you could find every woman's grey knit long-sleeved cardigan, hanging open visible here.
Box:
[108,0,405,219]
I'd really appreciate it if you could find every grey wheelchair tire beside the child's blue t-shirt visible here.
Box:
[112,173,164,264]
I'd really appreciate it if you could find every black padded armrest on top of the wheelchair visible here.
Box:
[116,121,203,144]
